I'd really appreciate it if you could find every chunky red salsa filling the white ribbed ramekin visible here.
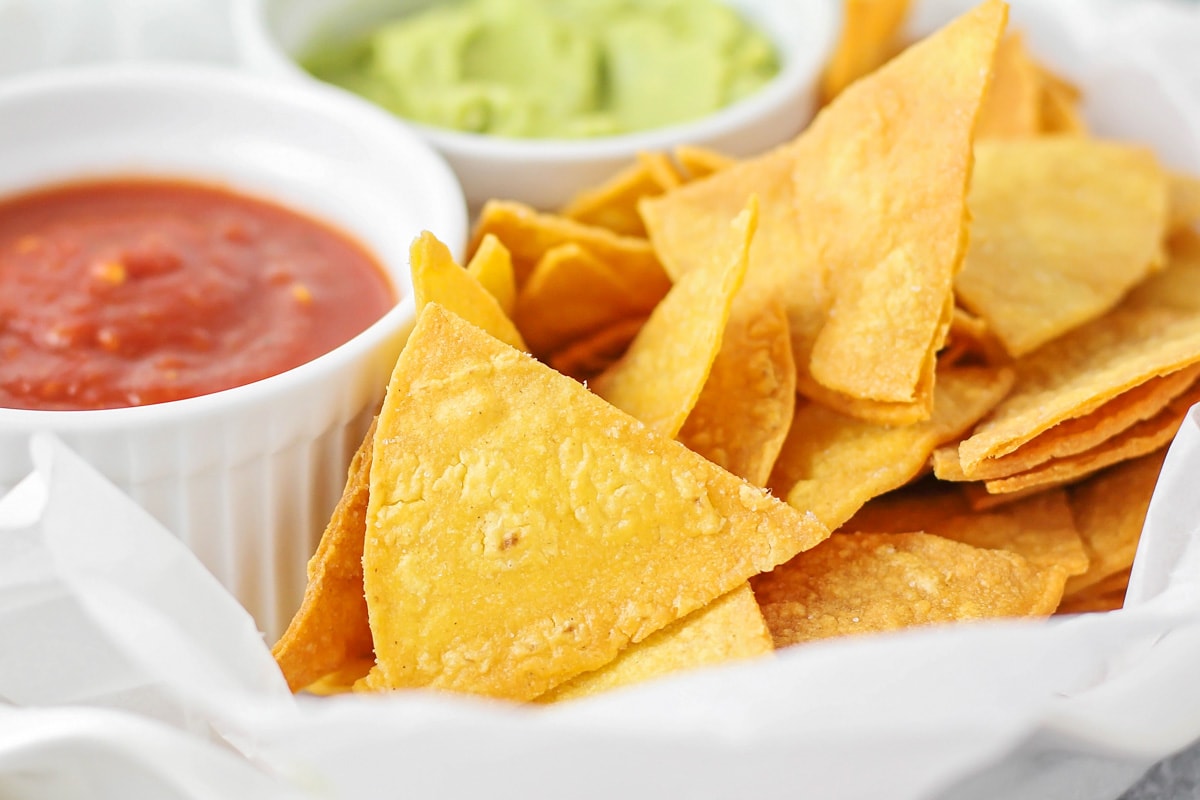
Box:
[0,179,396,409]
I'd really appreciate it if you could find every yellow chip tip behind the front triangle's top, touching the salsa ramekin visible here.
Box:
[409,230,527,350]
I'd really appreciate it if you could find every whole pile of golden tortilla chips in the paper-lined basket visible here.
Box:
[275,0,1200,702]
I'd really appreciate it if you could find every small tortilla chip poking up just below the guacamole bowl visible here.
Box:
[562,152,682,236]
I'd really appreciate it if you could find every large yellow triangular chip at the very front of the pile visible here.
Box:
[362,303,828,699]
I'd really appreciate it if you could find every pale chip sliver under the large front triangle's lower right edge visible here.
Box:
[538,583,774,703]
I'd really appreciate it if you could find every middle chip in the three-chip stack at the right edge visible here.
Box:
[934,365,1200,481]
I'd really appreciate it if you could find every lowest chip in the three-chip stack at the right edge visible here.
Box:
[984,386,1200,494]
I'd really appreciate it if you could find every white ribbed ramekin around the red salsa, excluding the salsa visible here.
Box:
[0,65,467,637]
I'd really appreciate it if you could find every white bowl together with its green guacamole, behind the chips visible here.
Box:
[235,0,840,209]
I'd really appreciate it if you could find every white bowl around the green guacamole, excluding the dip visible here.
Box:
[233,0,841,209]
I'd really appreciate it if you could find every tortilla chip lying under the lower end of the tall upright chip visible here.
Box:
[768,367,1013,529]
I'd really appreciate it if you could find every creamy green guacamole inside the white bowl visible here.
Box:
[301,0,779,138]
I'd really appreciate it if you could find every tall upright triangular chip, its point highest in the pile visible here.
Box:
[640,0,1006,415]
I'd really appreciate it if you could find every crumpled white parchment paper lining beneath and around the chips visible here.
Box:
[0,0,1200,800]
